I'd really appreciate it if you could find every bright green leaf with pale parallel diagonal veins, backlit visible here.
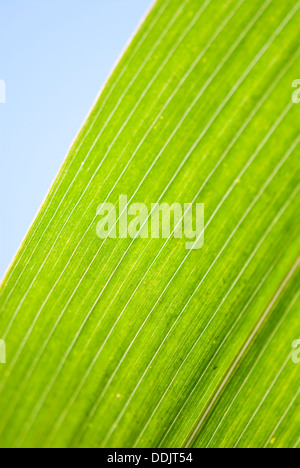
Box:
[0,0,300,448]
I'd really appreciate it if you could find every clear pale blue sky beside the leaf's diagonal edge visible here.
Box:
[0,0,153,279]
